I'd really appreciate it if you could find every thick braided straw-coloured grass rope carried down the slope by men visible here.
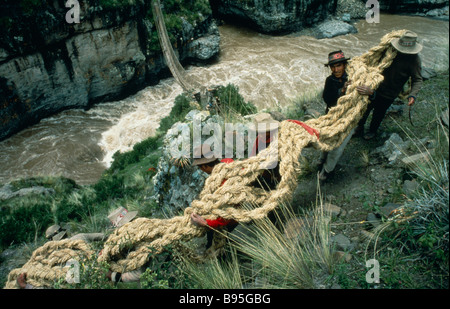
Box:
[6,30,406,288]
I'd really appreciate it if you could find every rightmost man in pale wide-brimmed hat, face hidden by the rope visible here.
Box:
[357,30,422,140]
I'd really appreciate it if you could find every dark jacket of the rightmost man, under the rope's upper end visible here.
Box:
[376,53,422,100]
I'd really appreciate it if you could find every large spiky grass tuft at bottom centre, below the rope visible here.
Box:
[232,200,333,288]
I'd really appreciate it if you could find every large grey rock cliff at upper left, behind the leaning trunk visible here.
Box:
[0,0,220,140]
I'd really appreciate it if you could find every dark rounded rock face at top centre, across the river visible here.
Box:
[210,0,337,34]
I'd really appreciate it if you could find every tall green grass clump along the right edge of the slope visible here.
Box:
[364,97,449,268]
